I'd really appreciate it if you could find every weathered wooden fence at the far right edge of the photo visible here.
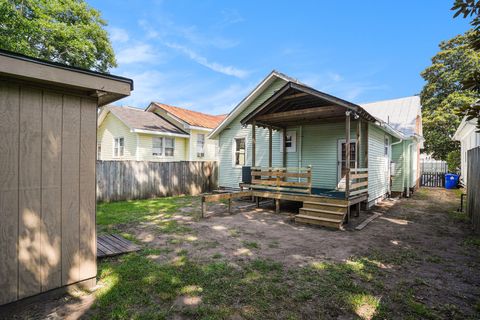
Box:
[467,147,480,233]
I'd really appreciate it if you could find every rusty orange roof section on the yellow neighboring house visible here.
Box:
[153,102,227,129]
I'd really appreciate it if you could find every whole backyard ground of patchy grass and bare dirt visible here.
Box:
[4,189,480,320]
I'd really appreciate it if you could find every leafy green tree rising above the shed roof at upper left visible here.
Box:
[0,0,116,72]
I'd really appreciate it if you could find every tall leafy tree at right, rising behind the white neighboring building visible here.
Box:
[420,31,480,160]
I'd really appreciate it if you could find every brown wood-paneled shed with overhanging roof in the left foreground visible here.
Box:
[0,51,133,305]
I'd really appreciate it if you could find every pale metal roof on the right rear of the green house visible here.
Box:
[359,96,422,136]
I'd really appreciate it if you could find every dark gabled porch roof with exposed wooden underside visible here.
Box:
[241,82,376,128]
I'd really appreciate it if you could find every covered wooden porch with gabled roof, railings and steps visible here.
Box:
[202,82,375,227]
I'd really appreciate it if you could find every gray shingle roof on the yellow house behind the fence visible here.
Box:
[106,106,187,134]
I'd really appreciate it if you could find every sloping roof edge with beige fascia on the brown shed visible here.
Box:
[0,50,133,106]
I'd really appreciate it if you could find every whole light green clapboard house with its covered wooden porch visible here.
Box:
[209,71,422,226]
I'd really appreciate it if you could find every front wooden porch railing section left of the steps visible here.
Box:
[250,166,312,194]
